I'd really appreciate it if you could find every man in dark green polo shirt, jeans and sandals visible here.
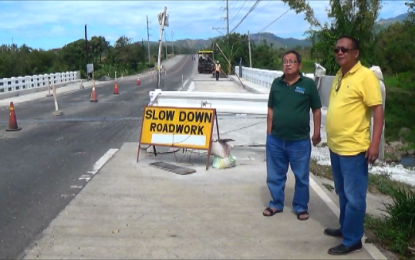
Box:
[263,51,321,220]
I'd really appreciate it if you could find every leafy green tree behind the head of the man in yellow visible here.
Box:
[283,0,381,74]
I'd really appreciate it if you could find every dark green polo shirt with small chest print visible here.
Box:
[268,74,321,141]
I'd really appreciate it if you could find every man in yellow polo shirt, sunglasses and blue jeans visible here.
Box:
[324,36,384,255]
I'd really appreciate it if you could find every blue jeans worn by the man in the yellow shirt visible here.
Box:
[330,151,369,246]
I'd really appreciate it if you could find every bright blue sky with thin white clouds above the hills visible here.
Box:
[0,0,407,50]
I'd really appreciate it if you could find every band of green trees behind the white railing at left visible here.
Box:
[0,36,194,79]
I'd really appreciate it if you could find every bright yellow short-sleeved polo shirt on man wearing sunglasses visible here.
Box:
[326,62,382,155]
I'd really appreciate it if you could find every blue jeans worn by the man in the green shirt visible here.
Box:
[266,135,311,213]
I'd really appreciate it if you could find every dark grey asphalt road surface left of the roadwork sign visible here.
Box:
[0,55,195,259]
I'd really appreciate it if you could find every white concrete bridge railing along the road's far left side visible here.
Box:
[0,71,81,93]
